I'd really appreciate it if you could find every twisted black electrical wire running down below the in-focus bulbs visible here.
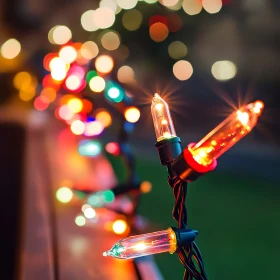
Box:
[168,166,207,280]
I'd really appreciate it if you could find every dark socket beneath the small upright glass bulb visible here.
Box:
[155,136,182,165]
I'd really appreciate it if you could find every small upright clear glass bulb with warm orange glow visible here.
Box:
[151,93,176,142]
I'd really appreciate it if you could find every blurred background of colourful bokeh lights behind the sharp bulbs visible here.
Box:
[0,0,280,280]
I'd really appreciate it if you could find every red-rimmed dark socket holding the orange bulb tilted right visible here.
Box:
[171,143,217,182]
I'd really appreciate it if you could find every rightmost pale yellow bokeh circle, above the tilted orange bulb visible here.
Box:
[211,60,237,81]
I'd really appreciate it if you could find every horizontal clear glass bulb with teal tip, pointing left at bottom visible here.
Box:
[103,228,177,259]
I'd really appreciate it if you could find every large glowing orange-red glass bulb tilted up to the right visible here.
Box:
[189,101,264,166]
